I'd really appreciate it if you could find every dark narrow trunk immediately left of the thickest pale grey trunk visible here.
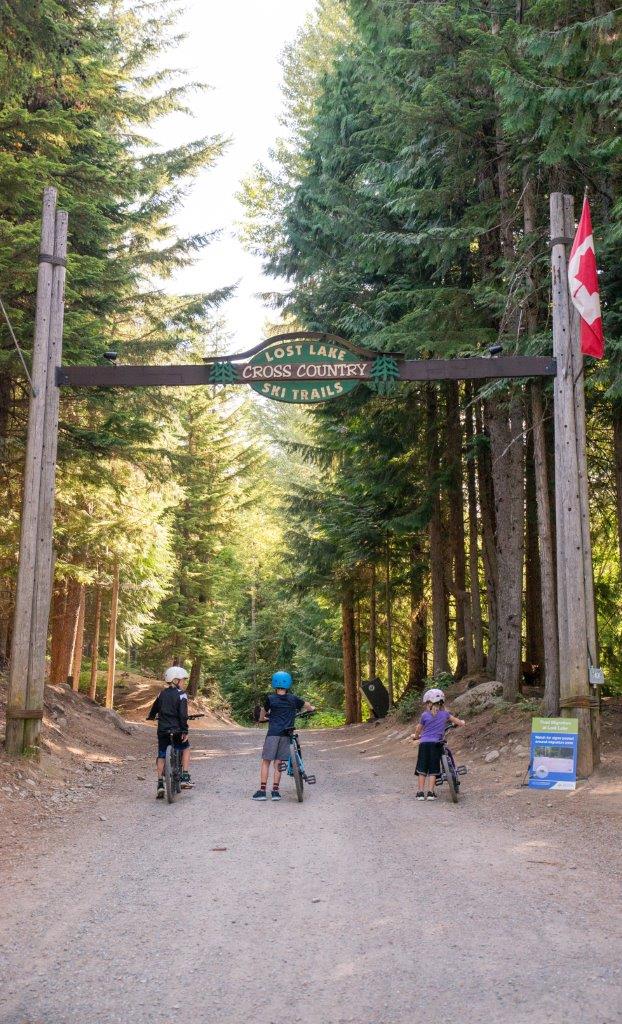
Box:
[475,403,499,679]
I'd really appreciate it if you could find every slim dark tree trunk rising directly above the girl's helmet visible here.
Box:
[425,384,449,676]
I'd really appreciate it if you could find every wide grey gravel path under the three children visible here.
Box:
[0,729,622,1024]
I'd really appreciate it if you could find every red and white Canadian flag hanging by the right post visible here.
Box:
[568,198,605,359]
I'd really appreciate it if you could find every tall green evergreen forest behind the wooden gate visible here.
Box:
[0,0,622,723]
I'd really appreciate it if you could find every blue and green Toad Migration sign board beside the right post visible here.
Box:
[529,718,579,790]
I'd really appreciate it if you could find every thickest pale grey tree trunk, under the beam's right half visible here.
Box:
[490,394,525,701]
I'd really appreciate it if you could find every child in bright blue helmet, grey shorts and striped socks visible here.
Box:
[253,672,316,800]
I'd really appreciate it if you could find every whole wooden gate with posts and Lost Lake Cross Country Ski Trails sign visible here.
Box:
[2,189,597,775]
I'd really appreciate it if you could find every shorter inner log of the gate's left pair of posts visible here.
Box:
[24,210,69,746]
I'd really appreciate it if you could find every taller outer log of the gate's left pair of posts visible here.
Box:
[6,188,56,754]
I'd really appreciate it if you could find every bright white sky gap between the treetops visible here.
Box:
[154,0,316,351]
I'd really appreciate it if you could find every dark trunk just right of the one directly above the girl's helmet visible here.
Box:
[445,381,472,679]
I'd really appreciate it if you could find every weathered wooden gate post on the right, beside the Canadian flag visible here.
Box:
[550,193,594,777]
